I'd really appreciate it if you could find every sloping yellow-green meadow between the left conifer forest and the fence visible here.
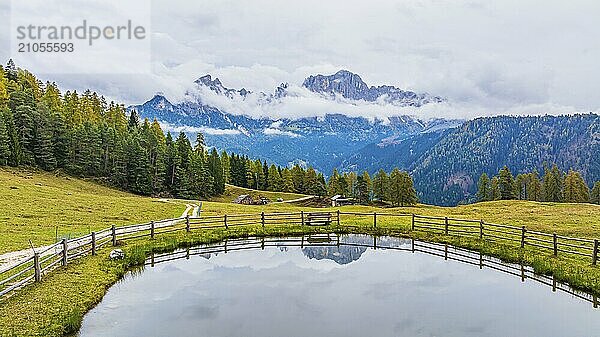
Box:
[0,168,185,254]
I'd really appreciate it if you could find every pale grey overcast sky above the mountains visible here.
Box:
[0,0,600,117]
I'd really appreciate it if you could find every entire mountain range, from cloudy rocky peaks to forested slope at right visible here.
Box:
[130,70,600,205]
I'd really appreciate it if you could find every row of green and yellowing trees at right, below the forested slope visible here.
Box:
[477,164,600,204]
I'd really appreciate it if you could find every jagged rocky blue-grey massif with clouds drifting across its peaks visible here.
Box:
[130,70,454,173]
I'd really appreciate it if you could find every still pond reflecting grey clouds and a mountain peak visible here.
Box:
[79,234,600,337]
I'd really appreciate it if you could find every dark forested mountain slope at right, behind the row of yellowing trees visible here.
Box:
[412,114,600,205]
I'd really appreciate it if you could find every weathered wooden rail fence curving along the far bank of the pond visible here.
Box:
[0,210,599,298]
